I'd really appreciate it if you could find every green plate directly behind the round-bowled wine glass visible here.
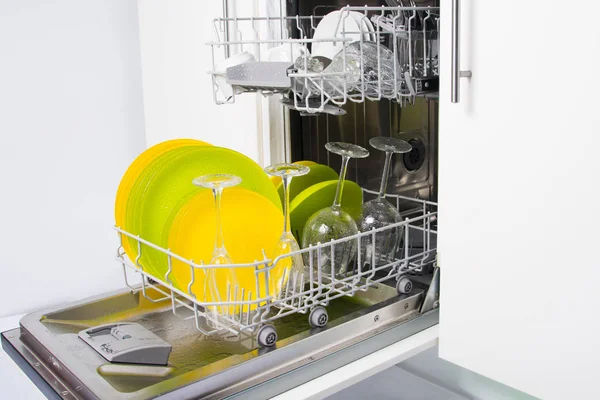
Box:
[290,180,362,243]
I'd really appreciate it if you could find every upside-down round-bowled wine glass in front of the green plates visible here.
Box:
[302,142,369,278]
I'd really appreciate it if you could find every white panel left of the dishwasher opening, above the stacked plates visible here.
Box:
[139,0,269,166]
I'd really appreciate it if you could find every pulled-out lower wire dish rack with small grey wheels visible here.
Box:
[115,189,437,347]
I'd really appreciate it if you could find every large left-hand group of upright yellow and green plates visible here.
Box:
[115,139,283,301]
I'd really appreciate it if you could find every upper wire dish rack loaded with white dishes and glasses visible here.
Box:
[207,6,440,113]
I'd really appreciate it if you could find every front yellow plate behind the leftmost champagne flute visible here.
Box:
[168,187,283,308]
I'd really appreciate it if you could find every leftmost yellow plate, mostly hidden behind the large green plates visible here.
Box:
[115,139,210,254]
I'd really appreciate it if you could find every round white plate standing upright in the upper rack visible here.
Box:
[311,10,374,59]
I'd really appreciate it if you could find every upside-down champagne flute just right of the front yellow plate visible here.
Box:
[265,163,310,301]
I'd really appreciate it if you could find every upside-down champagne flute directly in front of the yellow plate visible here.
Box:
[192,174,242,329]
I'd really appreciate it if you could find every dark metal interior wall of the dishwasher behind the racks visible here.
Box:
[287,0,439,205]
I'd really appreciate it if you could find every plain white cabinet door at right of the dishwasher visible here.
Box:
[439,0,600,399]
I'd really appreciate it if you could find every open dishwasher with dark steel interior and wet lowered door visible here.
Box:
[2,0,439,399]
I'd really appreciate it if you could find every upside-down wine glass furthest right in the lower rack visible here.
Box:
[358,137,412,267]
